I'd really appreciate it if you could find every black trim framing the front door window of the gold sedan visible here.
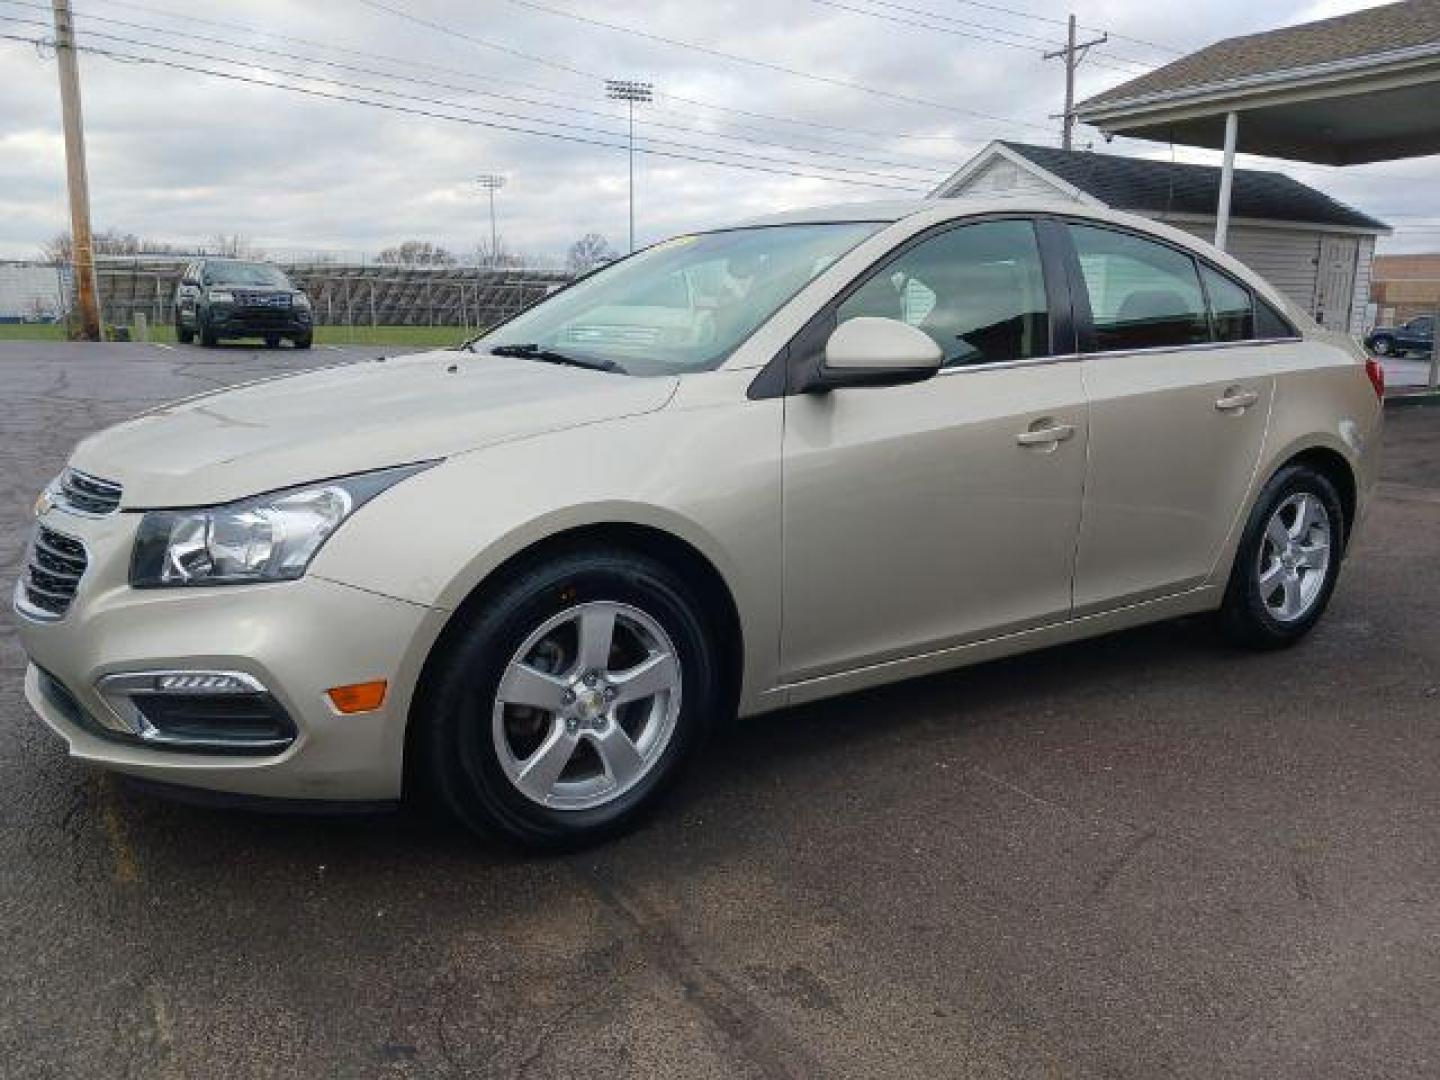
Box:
[746,210,1080,400]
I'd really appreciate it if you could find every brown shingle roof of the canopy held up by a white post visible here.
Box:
[1079,0,1440,112]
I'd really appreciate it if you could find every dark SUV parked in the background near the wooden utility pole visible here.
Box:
[176,259,314,348]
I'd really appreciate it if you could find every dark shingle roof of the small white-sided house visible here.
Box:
[1001,141,1390,232]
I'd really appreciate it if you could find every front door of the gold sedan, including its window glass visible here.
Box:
[780,219,1087,683]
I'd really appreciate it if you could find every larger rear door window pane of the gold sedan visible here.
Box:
[1068,225,1210,351]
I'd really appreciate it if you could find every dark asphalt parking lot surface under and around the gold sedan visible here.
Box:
[0,343,1440,1080]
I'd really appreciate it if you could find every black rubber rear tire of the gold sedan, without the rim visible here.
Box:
[1220,465,1349,649]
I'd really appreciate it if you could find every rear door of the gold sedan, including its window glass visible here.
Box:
[1067,222,1274,615]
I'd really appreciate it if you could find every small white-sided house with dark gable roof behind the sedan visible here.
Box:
[930,141,1390,333]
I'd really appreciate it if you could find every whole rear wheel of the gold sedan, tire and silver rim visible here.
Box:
[1221,465,1345,648]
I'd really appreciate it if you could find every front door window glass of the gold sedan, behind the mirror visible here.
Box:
[837,220,1050,367]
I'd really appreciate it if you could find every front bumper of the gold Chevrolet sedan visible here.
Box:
[16,510,445,802]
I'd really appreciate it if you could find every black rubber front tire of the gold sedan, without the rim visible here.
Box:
[412,549,724,848]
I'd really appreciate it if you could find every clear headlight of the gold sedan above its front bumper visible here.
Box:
[130,461,436,589]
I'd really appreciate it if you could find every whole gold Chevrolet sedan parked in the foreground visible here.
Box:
[14,199,1382,845]
